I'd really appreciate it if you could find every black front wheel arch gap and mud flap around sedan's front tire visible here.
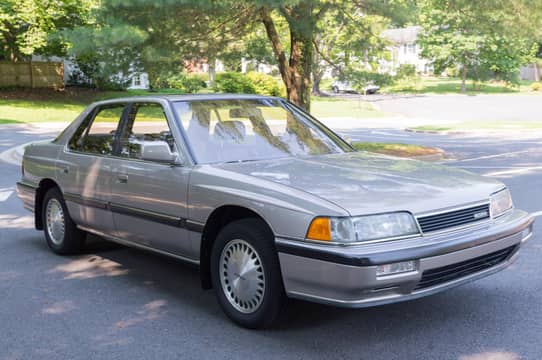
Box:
[200,205,274,289]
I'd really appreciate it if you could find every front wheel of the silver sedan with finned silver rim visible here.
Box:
[211,218,285,329]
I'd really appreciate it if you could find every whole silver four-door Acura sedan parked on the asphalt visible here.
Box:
[17,95,533,328]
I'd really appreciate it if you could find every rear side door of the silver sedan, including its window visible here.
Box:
[57,103,126,235]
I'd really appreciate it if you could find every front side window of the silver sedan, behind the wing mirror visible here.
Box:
[119,103,177,160]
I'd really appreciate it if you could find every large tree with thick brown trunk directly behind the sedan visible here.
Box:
[65,0,413,109]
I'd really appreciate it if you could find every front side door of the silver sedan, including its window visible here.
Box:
[111,102,195,258]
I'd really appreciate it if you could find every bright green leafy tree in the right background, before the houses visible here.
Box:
[419,0,530,91]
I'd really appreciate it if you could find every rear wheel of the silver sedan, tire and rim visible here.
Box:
[41,188,86,255]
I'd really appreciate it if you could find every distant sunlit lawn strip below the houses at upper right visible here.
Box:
[383,77,542,95]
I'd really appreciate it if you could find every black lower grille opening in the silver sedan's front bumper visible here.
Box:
[415,245,516,290]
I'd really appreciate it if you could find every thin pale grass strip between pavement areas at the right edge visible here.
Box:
[411,120,542,132]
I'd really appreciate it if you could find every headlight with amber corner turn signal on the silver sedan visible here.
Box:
[307,212,419,243]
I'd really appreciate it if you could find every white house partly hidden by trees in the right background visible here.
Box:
[379,26,432,75]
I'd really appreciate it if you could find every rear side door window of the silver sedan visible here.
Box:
[68,104,125,155]
